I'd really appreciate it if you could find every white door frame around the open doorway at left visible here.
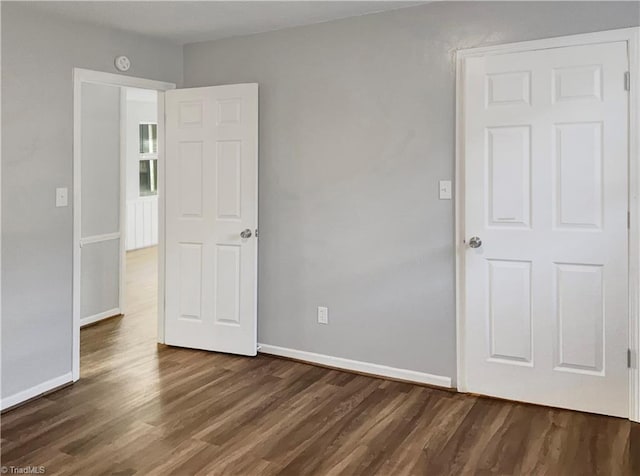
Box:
[71,68,176,382]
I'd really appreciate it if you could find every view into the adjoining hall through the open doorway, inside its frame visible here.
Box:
[80,83,158,376]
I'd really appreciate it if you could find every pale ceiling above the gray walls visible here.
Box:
[23,0,427,44]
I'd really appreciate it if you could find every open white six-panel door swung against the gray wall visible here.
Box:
[165,84,258,355]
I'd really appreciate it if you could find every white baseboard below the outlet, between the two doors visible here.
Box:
[258,344,452,388]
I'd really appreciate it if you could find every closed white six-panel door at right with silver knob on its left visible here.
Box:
[463,42,629,416]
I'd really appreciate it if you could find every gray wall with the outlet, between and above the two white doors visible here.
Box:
[184,2,640,377]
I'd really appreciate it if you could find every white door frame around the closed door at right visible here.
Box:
[455,27,640,422]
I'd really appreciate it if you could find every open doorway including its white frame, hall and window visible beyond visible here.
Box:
[73,69,175,381]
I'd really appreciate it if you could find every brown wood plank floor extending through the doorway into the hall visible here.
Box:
[1,248,640,476]
